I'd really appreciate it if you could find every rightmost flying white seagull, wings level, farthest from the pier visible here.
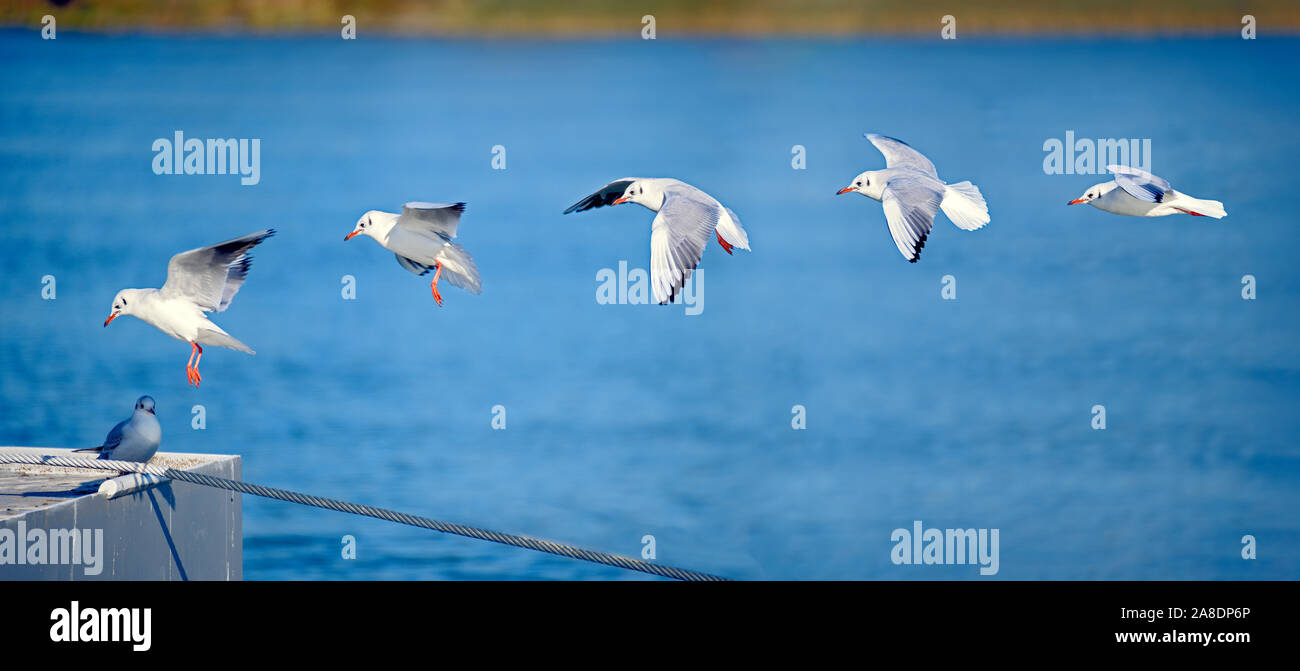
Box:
[1066,165,1227,218]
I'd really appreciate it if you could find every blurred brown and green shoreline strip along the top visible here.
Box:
[0,0,1300,39]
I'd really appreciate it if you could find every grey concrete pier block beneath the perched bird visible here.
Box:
[0,447,243,580]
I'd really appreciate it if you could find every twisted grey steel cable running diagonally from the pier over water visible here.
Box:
[0,453,727,581]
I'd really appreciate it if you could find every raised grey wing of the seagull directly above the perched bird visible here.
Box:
[161,229,276,312]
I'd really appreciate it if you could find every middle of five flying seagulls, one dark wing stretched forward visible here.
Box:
[564,177,749,304]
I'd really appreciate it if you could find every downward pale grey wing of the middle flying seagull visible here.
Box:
[650,187,722,304]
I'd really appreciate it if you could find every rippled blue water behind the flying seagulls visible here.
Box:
[0,31,1300,579]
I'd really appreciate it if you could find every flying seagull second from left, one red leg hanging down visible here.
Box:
[343,203,484,306]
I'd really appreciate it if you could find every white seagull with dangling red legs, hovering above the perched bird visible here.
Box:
[104,229,276,386]
